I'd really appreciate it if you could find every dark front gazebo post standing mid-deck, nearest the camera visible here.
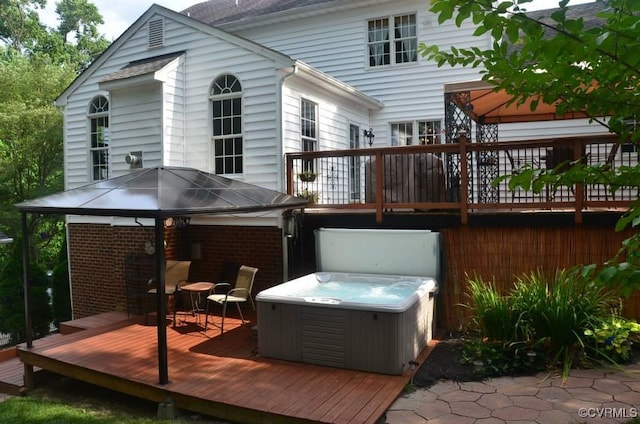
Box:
[155,217,169,385]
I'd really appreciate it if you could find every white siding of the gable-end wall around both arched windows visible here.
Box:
[65,13,282,189]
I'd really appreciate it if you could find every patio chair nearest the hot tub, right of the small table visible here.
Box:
[204,265,258,335]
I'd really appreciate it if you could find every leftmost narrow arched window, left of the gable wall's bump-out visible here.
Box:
[89,96,110,181]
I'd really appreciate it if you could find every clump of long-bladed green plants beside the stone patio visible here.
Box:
[466,267,624,378]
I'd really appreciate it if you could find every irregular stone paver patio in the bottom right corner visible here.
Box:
[386,363,640,424]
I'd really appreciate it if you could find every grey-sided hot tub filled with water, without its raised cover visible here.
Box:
[256,272,437,374]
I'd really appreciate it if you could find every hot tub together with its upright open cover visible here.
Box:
[256,229,440,374]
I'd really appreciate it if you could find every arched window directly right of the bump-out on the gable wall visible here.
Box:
[209,74,244,174]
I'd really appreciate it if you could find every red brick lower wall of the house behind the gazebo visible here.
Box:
[69,224,283,319]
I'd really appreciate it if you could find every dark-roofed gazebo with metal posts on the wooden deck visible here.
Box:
[15,167,307,385]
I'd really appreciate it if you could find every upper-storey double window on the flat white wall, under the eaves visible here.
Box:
[367,13,418,67]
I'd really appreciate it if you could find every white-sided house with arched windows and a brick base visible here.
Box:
[56,0,594,316]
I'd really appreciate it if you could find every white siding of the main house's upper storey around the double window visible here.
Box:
[232,0,482,146]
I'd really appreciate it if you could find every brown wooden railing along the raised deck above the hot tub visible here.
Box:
[286,136,638,223]
